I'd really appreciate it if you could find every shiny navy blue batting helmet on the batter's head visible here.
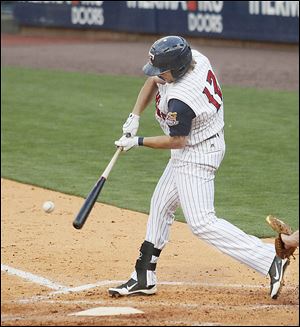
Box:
[143,36,192,79]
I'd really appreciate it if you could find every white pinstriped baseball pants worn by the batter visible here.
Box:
[131,135,275,285]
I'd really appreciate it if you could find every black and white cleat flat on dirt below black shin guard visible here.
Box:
[108,278,157,297]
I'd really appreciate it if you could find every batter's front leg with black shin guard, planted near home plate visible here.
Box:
[109,163,179,296]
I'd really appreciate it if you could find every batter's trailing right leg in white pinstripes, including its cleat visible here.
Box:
[176,152,289,299]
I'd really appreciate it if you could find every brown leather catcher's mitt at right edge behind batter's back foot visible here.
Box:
[266,215,296,259]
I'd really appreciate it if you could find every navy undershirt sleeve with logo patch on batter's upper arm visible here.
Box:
[166,99,196,136]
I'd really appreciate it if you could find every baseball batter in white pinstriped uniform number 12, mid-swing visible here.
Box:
[109,36,289,299]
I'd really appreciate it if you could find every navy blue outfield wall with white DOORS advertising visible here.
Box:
[14,1,299,44]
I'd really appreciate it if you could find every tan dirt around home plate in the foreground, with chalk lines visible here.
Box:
[1,179,299,326]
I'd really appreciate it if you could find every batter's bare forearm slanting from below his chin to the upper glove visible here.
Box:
[132,77,157,116]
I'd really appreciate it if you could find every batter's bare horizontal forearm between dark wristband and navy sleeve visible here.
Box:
[143,135,187,149]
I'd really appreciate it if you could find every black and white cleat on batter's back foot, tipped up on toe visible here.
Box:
[269,255,290,299]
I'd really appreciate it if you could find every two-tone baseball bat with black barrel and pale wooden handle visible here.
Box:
[73,148,122,229]
